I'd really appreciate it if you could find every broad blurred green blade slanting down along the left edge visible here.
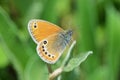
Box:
[0,7,33,80]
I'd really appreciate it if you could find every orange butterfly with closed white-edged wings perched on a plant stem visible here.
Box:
[28,19,73,64]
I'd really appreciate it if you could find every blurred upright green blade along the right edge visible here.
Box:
[106,4,120,80]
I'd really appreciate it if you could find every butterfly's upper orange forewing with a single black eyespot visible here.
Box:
[28,19,63,43]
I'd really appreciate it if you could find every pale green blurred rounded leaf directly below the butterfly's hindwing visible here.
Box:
[24,55,49,80]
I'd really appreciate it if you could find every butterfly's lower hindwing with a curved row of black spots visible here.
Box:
[37,33,67,64]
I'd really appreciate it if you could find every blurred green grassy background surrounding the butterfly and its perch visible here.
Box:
[0,0,120,80]
